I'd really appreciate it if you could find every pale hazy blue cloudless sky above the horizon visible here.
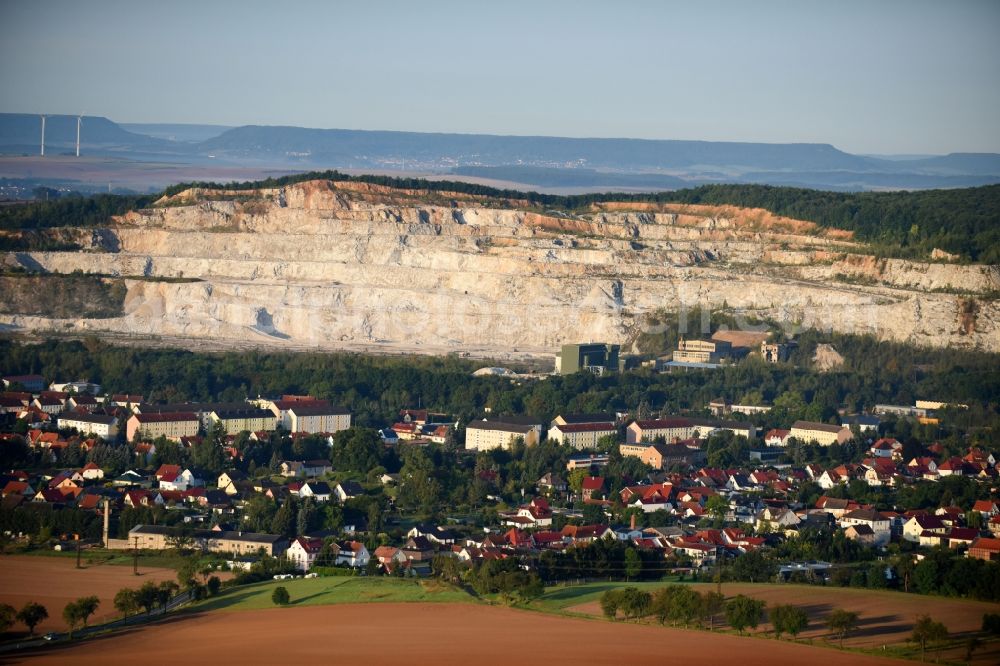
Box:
[0,0,1000,153]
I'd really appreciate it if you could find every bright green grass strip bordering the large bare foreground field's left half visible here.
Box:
[192,577,475,611]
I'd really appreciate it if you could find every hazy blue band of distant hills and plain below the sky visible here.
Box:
[0,113,1000,191]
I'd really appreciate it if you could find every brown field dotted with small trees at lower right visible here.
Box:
[566,583,1000,664]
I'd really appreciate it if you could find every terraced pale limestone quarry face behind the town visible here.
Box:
[0,181,1000,358]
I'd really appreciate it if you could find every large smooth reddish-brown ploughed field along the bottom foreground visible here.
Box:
[9,603,902,666]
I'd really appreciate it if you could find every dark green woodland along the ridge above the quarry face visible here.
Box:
[0,171,1000,263]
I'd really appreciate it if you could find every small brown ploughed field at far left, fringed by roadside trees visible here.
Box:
[0,555,182,634]
